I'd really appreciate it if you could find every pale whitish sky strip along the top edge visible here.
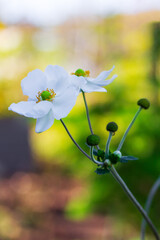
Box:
[0,0,160,26]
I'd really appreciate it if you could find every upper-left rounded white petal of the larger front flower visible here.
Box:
[21,69,47,100]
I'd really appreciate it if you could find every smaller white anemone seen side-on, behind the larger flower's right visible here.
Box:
[71,66,117,93]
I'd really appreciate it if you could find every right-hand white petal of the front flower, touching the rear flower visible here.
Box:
[52,87,79,120]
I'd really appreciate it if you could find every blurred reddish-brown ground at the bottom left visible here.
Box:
[0,171,114,240]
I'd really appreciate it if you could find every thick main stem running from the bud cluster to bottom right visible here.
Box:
[110,167,160,240]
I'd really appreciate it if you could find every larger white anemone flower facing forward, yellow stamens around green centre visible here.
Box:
[8,65,79,133]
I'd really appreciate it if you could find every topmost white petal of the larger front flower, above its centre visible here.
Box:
[45,65,69,94]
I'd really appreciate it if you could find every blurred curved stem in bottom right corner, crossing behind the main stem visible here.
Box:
[141,177,160,240]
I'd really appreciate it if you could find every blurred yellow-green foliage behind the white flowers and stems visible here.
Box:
[0,12,160,239]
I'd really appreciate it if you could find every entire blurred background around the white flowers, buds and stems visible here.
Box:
[0,0,160,240]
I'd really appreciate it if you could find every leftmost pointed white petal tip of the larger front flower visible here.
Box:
[8,101,36,117]
